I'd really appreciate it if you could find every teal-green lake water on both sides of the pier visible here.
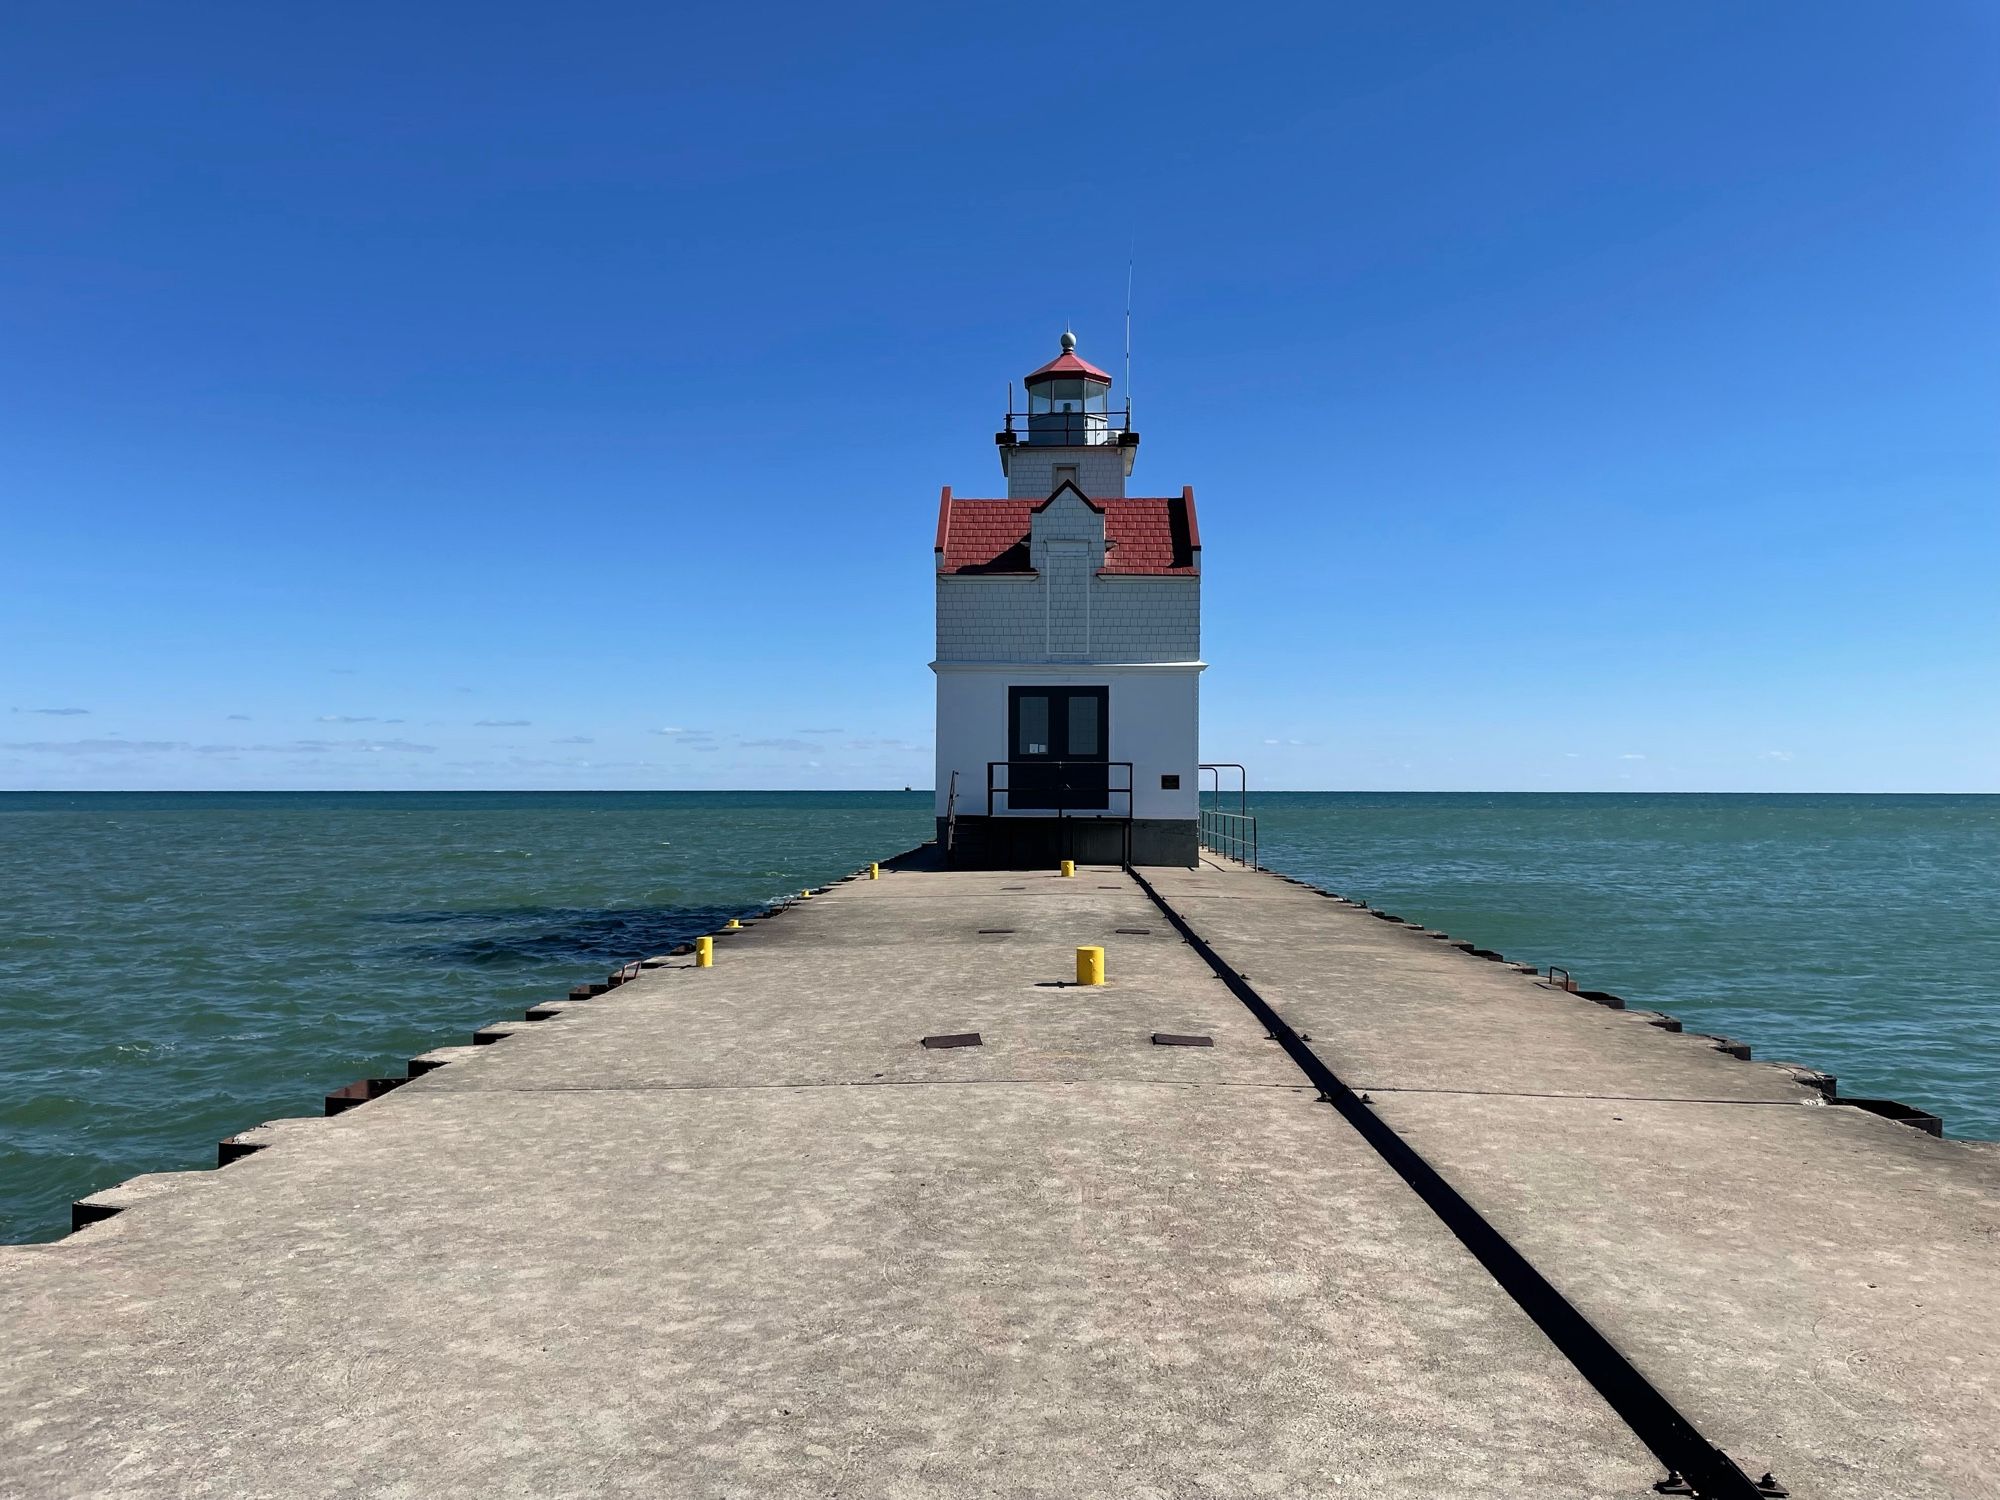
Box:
[0,792,2000,1240]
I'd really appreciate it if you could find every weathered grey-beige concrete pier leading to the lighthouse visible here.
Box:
[0,866,2000,1498]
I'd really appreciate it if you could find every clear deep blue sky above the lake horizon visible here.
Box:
[0,0,2000,790]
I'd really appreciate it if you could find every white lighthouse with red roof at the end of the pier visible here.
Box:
[930,332,1204,868]
